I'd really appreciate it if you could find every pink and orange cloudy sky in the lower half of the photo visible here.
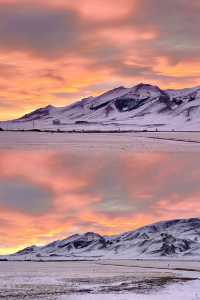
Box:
[0,150,200,254]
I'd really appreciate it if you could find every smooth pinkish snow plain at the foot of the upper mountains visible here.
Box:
[0,131,200,153]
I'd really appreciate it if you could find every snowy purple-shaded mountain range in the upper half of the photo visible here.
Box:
[0,83,200,131]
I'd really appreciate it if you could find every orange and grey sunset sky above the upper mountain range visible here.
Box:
[0,0,200,120]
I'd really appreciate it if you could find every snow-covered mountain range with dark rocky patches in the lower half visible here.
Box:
[4,218,200,260]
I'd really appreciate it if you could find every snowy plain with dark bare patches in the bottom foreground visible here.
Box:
[0,260,200,300]
